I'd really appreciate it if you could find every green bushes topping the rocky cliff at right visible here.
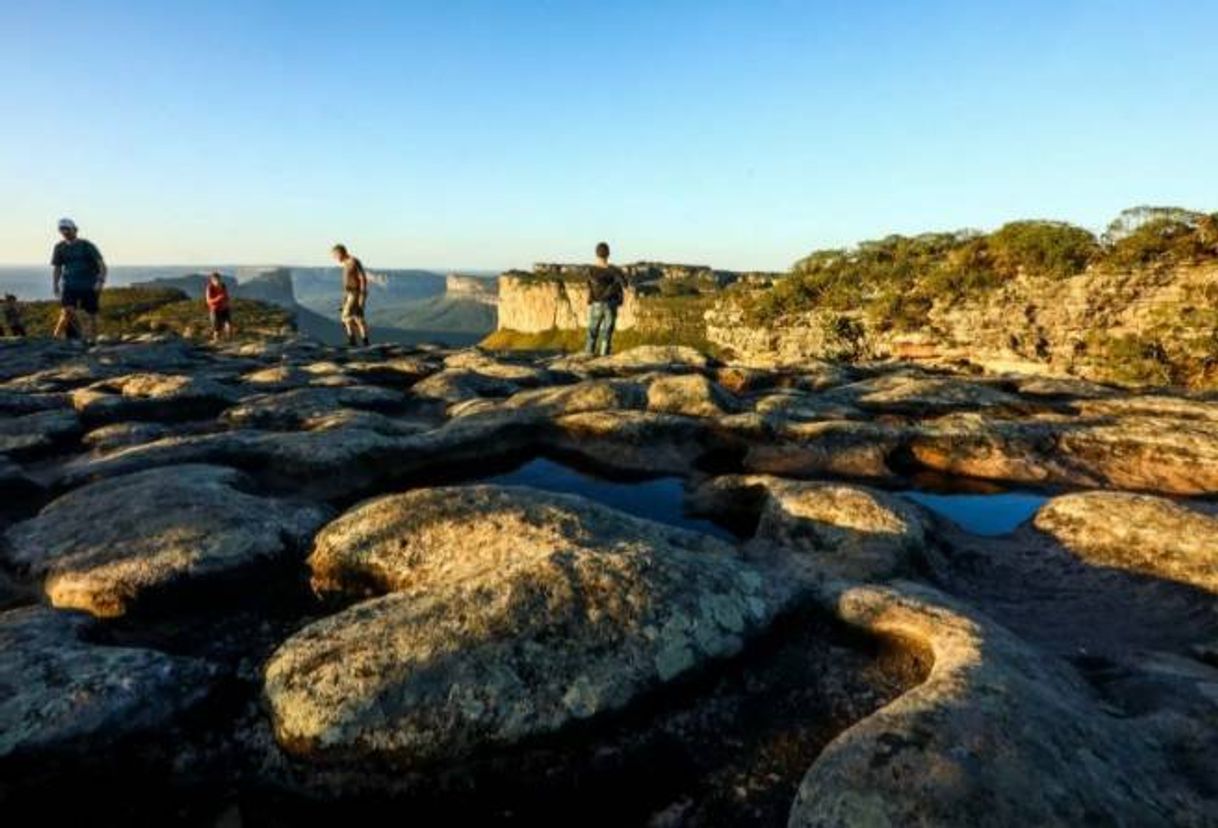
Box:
[739,207,1218,330]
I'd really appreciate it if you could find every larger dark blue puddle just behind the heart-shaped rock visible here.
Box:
[477,458,739,541]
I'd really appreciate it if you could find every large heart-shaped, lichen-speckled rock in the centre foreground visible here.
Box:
[266,486,789,766]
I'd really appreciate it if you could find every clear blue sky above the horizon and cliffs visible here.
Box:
[0,0,1218,269]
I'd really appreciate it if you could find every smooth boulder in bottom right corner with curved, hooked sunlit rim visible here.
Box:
[788,582,1218,828]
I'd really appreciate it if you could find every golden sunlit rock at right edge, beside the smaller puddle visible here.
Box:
[1034,492,1218,593]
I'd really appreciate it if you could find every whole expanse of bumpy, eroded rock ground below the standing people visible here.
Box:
[0,337,1218,827]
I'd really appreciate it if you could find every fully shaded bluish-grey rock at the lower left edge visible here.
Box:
[0,606,218,759]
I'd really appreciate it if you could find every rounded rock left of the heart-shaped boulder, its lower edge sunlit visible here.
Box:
[5,465,328,616]
